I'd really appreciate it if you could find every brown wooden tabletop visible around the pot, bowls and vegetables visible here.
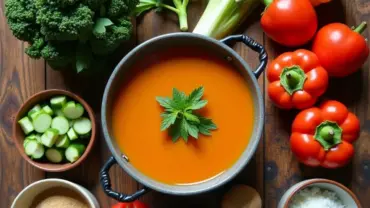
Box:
[0,0,370,208]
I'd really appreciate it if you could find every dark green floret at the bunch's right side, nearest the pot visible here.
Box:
[90,17,132,55]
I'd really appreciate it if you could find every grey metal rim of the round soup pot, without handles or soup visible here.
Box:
[101,32,264,195]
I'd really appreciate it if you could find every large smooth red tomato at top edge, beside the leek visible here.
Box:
[261,0,317,46]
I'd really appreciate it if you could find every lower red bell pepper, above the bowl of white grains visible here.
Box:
[290,100,360,168]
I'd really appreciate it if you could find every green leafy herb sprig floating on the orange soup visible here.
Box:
[156,87,217,142]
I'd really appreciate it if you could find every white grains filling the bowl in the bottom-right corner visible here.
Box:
[289,186,346,208]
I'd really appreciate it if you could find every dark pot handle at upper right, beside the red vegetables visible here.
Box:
[220,35,268,79]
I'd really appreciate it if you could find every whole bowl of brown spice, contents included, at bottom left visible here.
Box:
[11,178,100,208]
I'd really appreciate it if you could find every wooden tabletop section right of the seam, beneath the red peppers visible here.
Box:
[265,0,370,207]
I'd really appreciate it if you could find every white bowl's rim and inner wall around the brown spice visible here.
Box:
[11,178,100,208]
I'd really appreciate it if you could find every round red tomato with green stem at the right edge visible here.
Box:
[312,22,369,77]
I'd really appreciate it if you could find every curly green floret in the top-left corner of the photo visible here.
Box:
[5,0,40,41]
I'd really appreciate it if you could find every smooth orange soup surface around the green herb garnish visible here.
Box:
[112,49,253,185]
